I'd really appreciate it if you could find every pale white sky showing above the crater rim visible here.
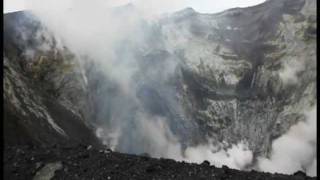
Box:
[3,0,265,13]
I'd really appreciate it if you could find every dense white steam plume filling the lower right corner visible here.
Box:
[258,107,317,176]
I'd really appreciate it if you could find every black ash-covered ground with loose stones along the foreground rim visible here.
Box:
[3,144,316,180]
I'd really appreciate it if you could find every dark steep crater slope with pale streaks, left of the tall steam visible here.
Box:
[3,12,100,148]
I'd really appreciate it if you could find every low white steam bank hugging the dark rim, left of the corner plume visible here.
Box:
[97,114,253,169]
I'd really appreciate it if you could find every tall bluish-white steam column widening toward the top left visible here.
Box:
[28,0,190,158]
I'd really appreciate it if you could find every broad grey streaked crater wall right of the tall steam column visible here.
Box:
[161,0,316,155]
